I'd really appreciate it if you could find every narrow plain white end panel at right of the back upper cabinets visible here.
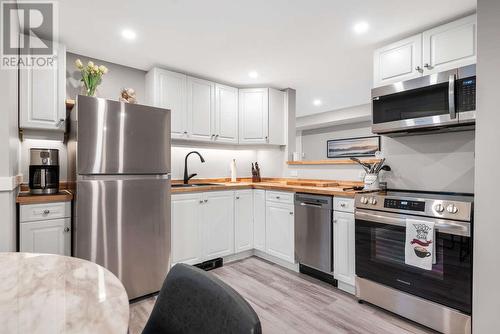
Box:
[268,88,286,145]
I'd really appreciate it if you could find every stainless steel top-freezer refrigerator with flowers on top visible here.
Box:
[68,96,170,299]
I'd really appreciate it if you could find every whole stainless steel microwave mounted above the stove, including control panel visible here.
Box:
[372,65,476,136]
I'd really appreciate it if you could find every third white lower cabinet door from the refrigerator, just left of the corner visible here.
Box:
[234,190,253,252]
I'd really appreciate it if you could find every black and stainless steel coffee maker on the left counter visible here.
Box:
[29,148,59,194]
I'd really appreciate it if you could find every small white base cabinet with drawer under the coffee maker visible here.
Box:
[19,202,71,256]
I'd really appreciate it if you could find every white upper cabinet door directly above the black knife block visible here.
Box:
[239,88,269,143]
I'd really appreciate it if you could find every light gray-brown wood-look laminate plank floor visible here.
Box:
[130,257,436,334]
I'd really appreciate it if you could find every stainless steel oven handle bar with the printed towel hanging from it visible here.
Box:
[355,209,471,237]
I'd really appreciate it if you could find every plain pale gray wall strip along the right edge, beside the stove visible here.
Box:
[472,0,500,334]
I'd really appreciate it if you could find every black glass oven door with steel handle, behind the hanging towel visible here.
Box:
[355,209,472,314]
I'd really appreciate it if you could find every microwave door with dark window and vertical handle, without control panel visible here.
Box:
[372,69,458,133]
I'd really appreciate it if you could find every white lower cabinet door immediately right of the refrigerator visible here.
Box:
[171,193,203,265]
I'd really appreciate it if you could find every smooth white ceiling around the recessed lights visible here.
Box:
[59,0,476,116]
